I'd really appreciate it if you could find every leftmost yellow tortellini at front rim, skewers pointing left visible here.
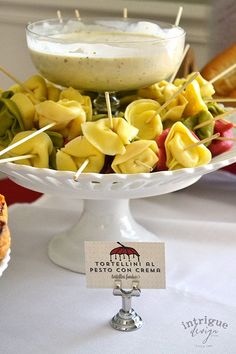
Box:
[2,130,53,168]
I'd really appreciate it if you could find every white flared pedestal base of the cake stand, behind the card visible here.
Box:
[48,199,158,273]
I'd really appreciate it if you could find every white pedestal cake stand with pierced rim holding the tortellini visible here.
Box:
[0,147,236,273]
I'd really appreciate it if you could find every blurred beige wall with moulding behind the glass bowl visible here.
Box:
[0,0,212,89]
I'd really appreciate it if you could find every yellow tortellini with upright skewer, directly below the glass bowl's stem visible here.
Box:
[82,117,138,156]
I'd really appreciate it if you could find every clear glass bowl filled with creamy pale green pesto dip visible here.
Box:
[26,18,185,92]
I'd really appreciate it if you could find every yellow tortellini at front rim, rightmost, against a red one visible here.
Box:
[165,122,211,170]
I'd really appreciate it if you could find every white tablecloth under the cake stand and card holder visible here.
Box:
[0,172,236,354]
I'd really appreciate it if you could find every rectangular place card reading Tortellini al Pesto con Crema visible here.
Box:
[85,241,165,289]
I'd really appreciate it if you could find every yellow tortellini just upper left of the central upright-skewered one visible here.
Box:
[35,99,86,140]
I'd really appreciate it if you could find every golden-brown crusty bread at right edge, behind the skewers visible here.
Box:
[201,44,236,97]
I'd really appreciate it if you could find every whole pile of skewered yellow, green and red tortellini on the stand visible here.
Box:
[0,74,230,174]
